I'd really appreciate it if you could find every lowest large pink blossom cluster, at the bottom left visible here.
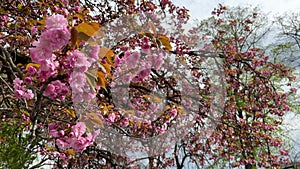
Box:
[48,122,100,152]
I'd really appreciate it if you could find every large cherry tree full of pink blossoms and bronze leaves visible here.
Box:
[0,0,295,169]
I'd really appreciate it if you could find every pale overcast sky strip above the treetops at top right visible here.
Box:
[172,0,300,19]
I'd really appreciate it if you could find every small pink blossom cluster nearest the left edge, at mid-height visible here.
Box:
[13,78,34,99]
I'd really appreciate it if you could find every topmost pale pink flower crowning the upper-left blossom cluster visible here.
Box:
[46,14,68,29]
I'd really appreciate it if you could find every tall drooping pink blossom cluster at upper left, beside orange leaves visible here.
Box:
[29,14,71,81]
